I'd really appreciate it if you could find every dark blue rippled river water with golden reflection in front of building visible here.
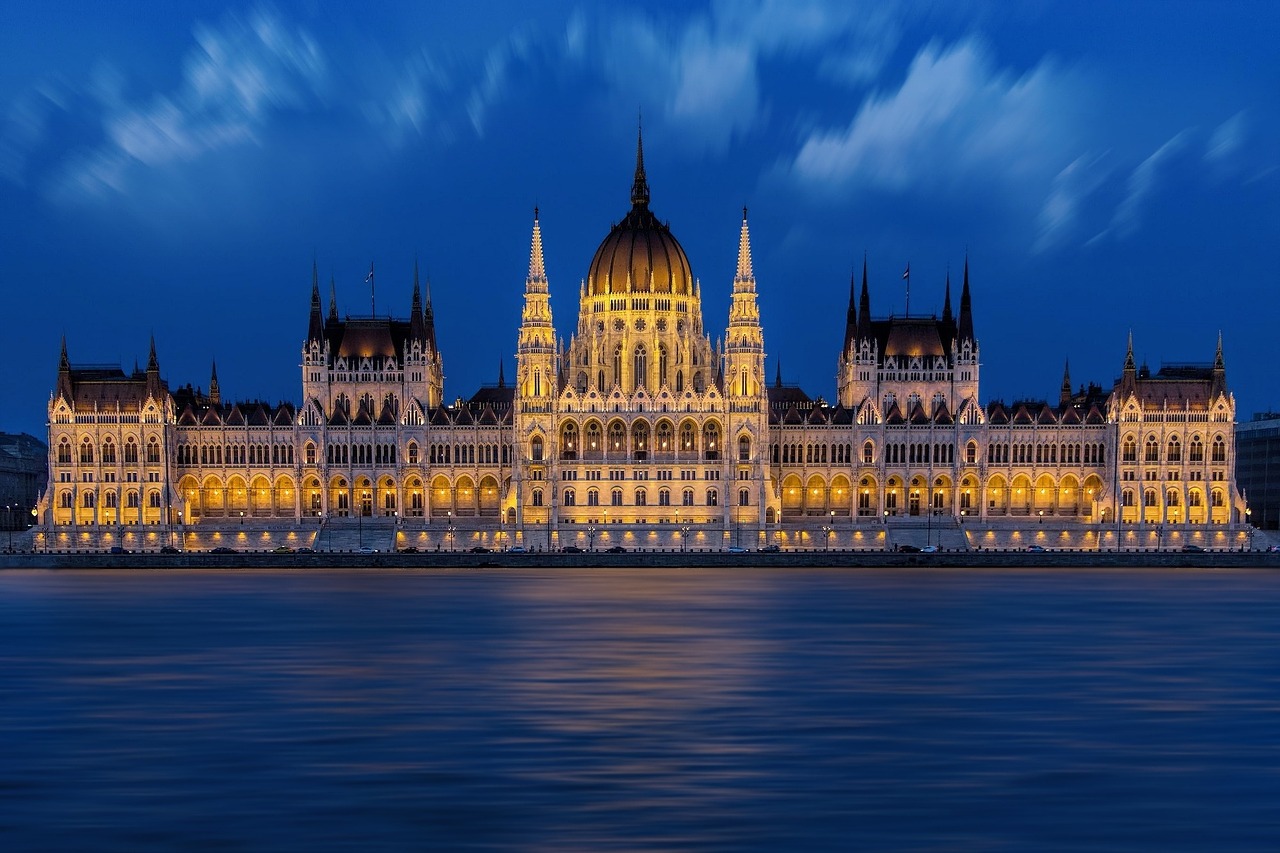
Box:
[0,560,1280,850]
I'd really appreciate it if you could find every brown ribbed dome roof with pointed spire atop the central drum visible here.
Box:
[586,134,694,296]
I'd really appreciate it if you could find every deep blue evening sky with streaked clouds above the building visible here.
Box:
[0,0,1280,435]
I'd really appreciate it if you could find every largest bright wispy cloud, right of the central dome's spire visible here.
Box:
[788,38,1078,199]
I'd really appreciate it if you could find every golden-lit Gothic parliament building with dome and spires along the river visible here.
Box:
[37,136,1247,551]
